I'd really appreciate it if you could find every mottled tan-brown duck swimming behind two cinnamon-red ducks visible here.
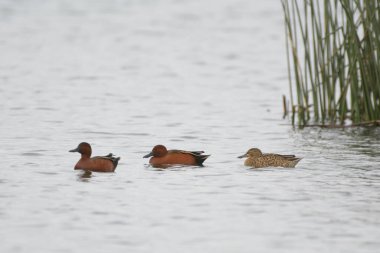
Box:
[238,148,302,168]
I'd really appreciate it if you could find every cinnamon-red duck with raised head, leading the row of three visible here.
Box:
[69,142,120,172]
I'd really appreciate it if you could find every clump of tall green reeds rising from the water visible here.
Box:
[281,0,380,126]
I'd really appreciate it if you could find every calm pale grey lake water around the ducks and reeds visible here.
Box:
[0,0,380,253]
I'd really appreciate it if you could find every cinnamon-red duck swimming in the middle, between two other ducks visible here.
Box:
[144,145,210,167]
